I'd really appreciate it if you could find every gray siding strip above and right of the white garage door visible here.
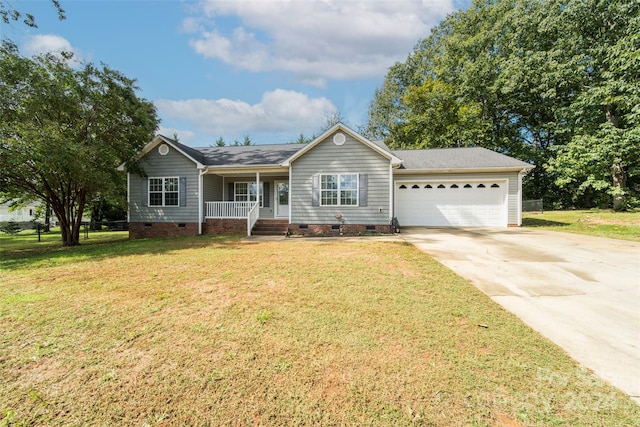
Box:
[393,172,521,225]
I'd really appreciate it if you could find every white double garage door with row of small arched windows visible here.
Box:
[394,181,507,227]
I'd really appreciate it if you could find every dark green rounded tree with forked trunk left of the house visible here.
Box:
[0,43,158,246]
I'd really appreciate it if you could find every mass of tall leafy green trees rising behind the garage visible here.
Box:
[367,0,640,207]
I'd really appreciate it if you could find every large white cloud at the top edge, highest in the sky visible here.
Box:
[183,0,454,85]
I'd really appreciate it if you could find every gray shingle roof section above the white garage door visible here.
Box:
[392,147,533,170]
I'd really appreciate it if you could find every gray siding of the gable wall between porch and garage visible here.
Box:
[289,134,391,225]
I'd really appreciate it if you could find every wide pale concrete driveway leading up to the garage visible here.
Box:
[401,227,640,403]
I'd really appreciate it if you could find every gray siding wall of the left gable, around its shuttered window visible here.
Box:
[129,148,198,223]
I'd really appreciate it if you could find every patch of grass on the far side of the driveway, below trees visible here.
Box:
[522,209,640,242]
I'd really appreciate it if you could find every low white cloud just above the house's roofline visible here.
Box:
[155,89,337,143]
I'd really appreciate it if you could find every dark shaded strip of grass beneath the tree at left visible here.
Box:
[0,235,243,270]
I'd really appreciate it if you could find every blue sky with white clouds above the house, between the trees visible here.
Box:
[0,0,468,147]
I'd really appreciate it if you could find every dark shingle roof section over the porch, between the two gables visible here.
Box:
[196,144,305,166]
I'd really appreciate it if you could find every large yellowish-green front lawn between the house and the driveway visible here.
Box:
[0,236,640,426]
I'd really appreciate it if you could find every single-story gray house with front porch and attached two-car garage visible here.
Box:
[119,124,534,238]
